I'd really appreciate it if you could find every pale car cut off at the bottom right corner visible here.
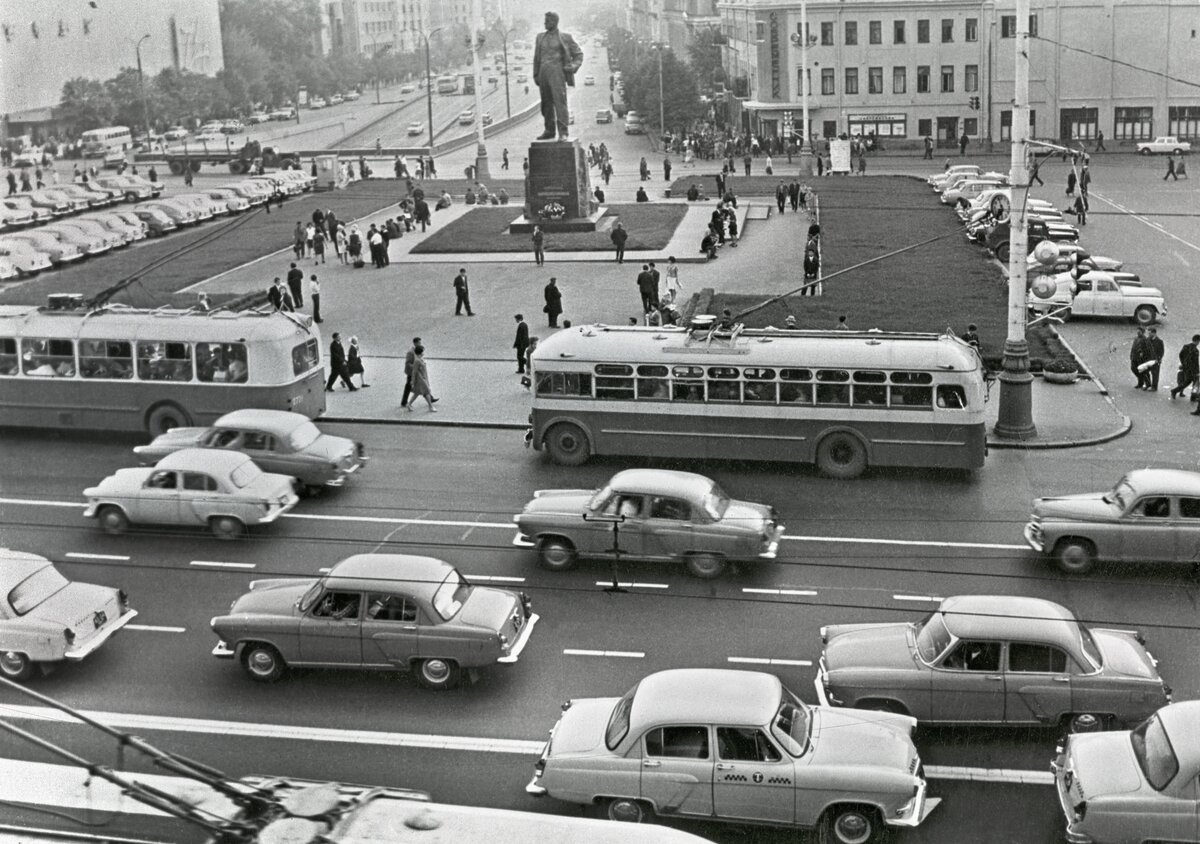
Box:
[1050,700,1200,844]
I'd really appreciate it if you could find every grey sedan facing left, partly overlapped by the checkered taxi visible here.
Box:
[816,595,1171,730]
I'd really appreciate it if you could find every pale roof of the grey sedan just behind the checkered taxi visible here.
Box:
[938,595,1078,651]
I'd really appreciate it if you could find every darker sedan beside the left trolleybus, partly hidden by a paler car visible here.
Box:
[133,410,367,492]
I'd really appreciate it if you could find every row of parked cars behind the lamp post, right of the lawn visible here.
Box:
[928,164,1166,325]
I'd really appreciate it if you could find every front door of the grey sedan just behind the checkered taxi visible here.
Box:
[930,639,1004,723]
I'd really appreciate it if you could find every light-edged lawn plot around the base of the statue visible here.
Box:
[412,203,688,255]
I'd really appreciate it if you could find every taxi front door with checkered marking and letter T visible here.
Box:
[713,726,796,824]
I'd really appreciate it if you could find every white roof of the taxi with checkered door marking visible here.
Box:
[629,669,782,736]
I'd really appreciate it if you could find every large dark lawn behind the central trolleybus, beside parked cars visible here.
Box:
[707,176,1064,366]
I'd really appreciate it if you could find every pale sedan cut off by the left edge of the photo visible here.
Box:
[0,549,138,682]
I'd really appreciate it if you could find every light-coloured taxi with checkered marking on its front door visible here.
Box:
[526,669,938,844]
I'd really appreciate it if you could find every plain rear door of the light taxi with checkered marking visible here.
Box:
[641,724,713,816]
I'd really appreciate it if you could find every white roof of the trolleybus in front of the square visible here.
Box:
[533,325,980,372]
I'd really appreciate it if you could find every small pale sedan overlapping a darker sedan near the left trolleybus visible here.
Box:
[83,449,298,539]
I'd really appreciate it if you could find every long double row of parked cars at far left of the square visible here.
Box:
[0,170,317,280]
